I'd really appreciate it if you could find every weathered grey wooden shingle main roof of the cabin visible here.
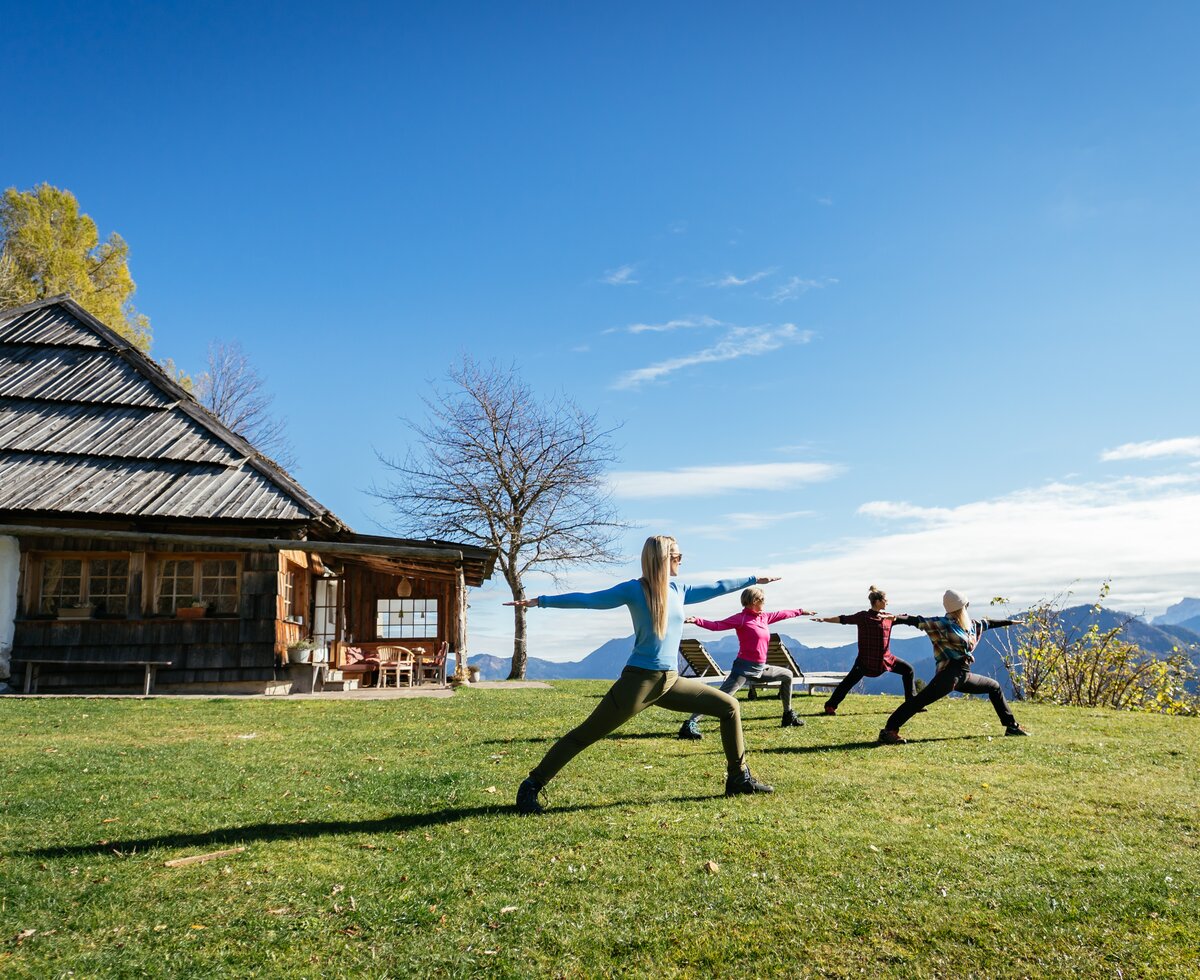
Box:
[0,297,349,534]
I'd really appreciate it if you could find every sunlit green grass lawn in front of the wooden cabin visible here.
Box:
[0,681,1200,978]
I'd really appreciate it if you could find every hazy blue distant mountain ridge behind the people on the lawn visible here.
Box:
[468,600,1200,695]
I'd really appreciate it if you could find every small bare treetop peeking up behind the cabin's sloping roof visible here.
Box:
[194,341,296,469]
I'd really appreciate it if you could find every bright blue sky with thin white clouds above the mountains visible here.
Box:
[0,0,1200,659]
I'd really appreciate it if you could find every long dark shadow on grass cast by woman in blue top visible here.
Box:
[21,794,720,858]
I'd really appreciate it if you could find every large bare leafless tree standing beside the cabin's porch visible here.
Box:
[373,356,625,680]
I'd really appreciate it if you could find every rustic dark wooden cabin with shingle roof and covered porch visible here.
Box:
[0,297,496,691]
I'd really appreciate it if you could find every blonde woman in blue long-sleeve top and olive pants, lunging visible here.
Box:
[504,535,776,813]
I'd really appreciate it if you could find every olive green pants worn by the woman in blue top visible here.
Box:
[529,667,746,786]
